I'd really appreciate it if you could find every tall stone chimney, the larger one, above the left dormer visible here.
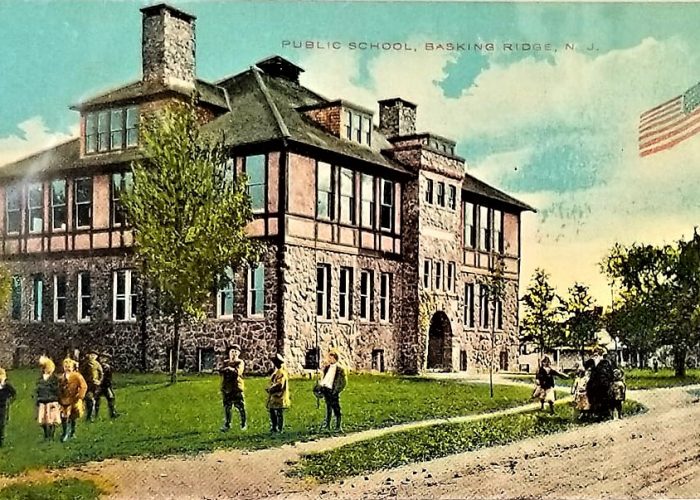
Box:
[141,3,196,90]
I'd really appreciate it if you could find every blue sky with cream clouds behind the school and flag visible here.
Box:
[0,0,700,300]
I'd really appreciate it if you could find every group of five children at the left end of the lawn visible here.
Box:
[0,351,118,446]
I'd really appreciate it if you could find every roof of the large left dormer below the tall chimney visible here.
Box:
[71,80,228,111]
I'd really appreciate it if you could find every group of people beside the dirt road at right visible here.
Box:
[532,349,627,420]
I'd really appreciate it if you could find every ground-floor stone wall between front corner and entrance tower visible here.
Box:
[283,245,403,372]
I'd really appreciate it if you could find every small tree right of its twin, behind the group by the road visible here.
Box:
[562,283,602,362]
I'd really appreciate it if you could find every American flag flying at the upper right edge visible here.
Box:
[639,83,700,157]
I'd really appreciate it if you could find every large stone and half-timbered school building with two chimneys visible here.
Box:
[0,4,532,373]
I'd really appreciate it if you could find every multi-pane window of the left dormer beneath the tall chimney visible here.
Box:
[85,106,139,154]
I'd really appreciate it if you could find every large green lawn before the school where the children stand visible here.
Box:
[0,371,531,474]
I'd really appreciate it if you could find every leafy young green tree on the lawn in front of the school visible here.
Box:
[121,104,261,383]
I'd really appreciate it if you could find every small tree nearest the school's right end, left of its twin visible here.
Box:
[521,269,562,356]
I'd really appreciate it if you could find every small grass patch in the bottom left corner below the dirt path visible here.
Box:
[0,478,103,500]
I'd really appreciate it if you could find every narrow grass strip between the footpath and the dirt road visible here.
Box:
[290,401,644,482]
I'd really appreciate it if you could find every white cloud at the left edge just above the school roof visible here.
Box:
[0,116,78,168]
